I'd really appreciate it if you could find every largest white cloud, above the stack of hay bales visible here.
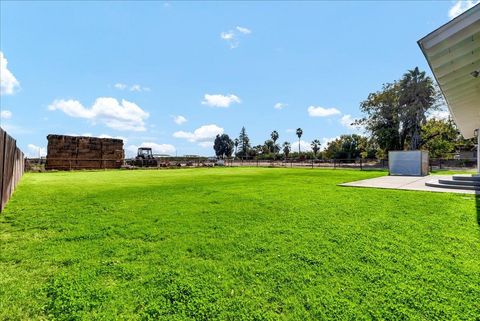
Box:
[48,97,149,131]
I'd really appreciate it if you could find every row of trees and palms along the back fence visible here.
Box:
[214,67,474,159]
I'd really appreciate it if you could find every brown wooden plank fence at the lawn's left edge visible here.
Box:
[0,128,25,212]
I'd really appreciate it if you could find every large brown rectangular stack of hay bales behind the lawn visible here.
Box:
[45,135,124,170]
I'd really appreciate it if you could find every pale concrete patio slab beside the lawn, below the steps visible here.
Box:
[339,175,479,194]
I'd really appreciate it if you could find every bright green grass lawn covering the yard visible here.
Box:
[0,168,480,320]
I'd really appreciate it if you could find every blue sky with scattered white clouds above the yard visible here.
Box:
[0,1,473,155]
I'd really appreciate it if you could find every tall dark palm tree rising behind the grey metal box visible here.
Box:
[399,67,437,150]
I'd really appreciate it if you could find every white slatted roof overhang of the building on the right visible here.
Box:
[418,4,480,138]
